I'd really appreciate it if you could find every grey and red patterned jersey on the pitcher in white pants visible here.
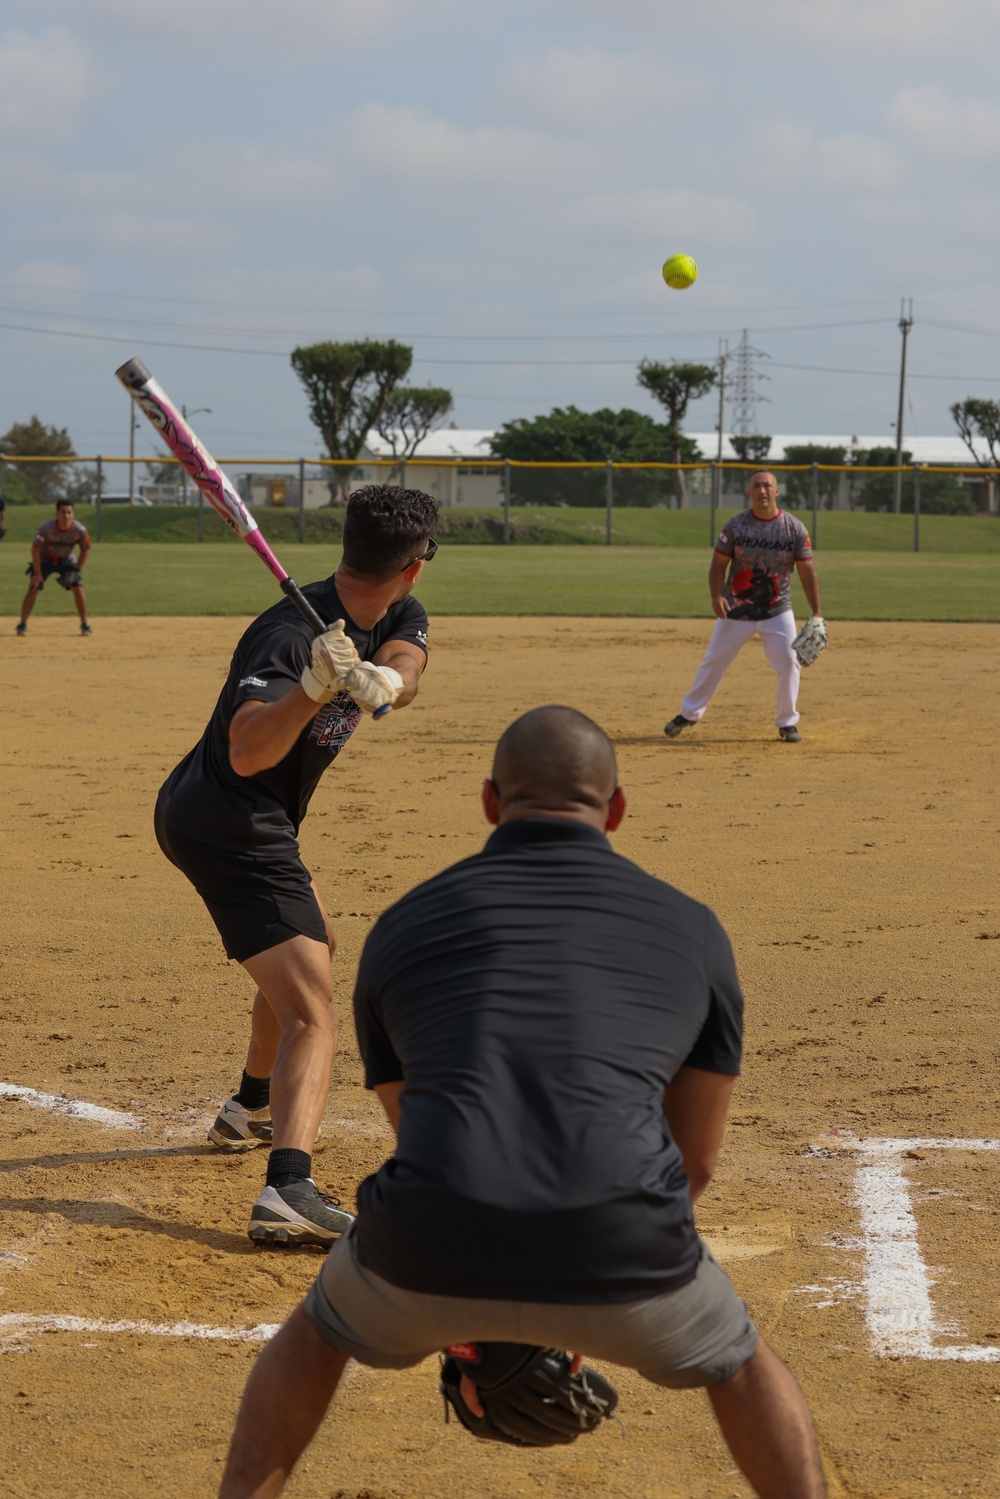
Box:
[715,510,813,619]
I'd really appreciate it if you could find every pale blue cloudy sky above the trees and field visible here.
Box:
[0,0,1000,457]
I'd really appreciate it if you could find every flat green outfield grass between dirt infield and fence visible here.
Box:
[0,542,1000,621]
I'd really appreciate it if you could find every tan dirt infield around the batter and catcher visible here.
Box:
[0,616,1000,1499]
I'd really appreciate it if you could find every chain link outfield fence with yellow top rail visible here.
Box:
[0,453,1000,550]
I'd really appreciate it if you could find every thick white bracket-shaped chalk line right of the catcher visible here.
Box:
[855,1138,1000,1363]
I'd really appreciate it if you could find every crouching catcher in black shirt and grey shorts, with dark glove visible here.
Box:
[220,708,826,1499]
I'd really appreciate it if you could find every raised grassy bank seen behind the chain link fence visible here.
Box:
[7,505,1000,558]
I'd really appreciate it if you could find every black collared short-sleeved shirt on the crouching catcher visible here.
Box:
[354,818,742,1303]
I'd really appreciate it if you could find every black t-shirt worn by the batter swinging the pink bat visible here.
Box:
[159,577,427,859]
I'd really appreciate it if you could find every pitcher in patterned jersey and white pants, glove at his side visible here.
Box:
[663,469,823,744]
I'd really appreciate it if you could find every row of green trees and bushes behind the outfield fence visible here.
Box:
[0,339,1000,514]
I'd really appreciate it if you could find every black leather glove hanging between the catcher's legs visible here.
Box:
[441,1343,618,1447]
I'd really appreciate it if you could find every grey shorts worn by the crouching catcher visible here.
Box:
[304,1234,757,1390]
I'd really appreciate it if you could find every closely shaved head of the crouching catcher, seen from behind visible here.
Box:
[492,705,618,820]
